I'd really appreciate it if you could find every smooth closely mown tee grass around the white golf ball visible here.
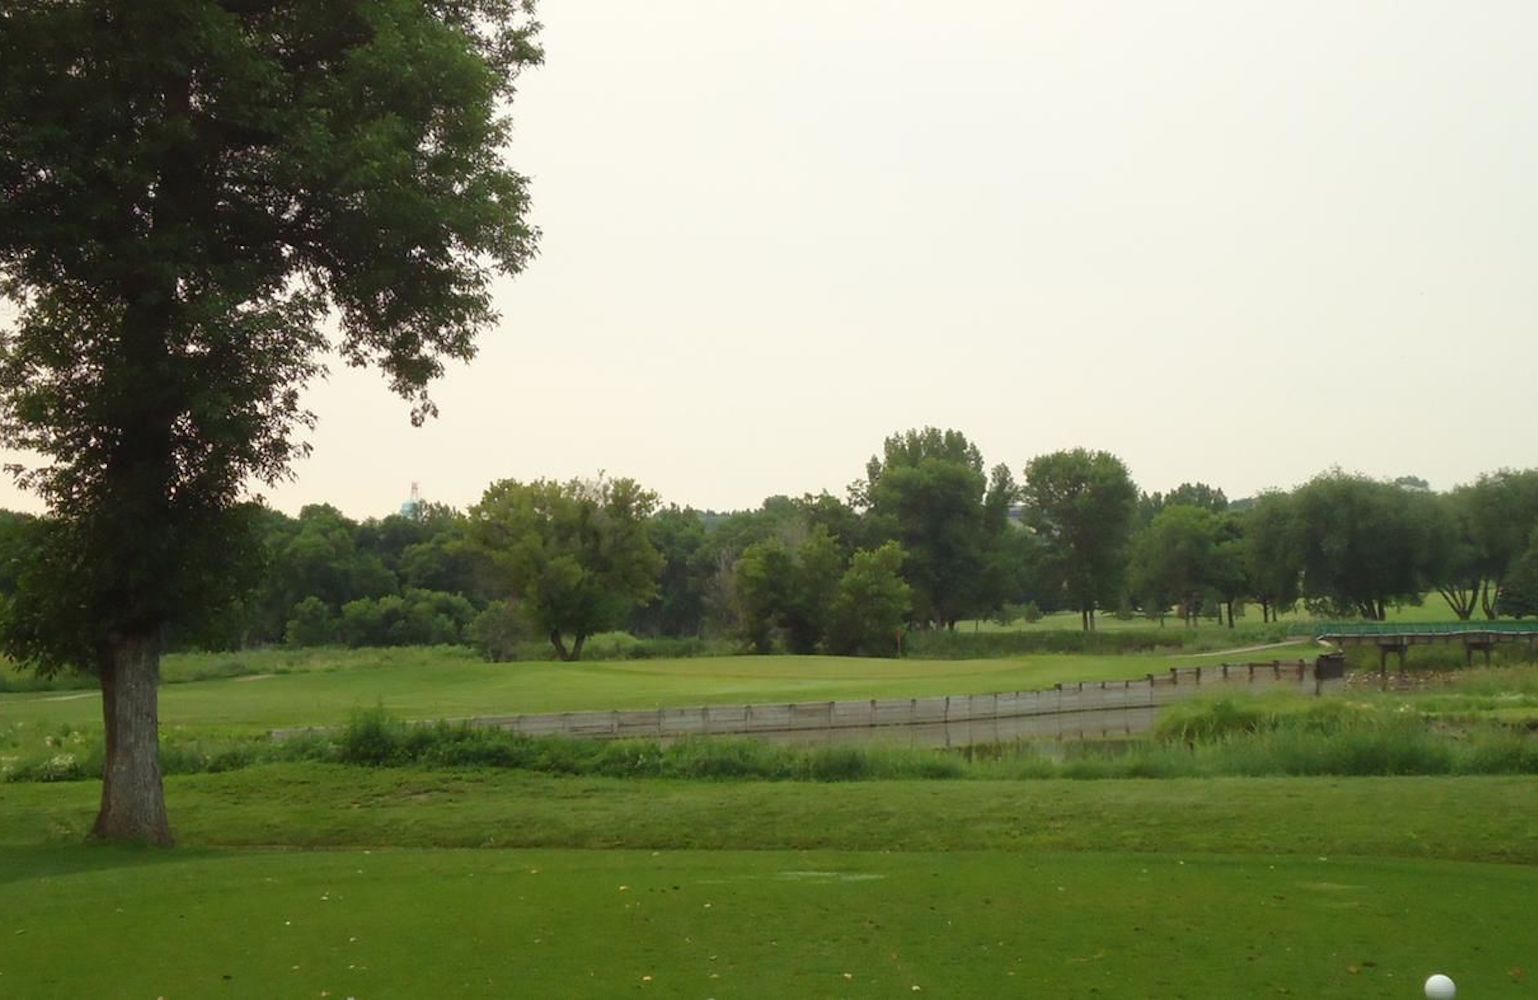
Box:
[0,849,1538,1000]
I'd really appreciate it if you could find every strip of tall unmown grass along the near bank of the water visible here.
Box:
[12,698,1538,782]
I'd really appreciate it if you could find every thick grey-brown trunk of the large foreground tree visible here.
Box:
[91,635,171,846]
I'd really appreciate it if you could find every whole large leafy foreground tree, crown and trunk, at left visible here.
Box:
[0,0,538,843]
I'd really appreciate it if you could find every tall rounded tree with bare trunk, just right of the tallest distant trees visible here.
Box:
[1021,448,1138,629]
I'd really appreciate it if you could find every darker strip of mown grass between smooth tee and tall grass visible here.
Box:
[0,763,1538,865]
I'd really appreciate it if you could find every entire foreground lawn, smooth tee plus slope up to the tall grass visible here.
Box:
[0,765,1538,1000]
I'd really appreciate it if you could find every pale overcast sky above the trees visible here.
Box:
[0,0,1538,517]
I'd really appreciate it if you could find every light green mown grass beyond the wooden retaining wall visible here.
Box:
[0,645,1312,731]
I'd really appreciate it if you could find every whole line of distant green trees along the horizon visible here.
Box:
[0,428,1538,660]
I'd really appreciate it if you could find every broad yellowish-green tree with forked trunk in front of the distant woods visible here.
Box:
[469,478,663,662]
